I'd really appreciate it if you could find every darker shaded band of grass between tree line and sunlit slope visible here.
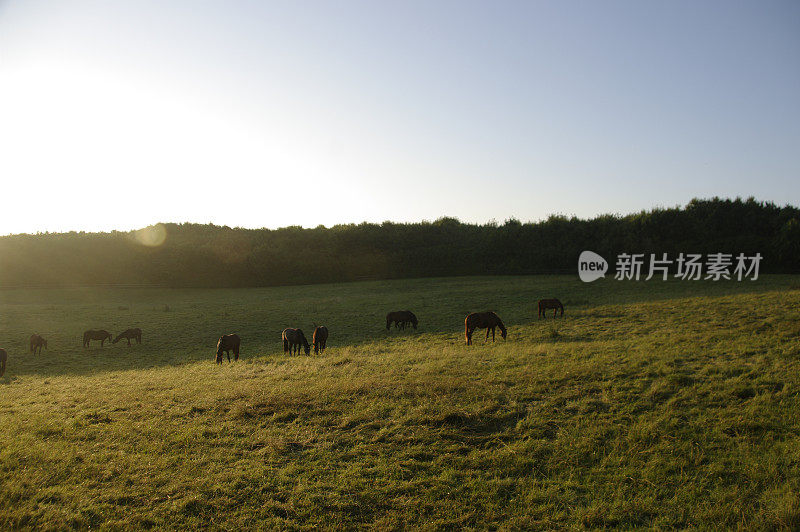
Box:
[0,275,799,378]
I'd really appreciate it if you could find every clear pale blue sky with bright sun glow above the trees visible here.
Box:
[0,0,800,234]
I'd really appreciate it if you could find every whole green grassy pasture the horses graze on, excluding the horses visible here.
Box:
[0,276,800,530]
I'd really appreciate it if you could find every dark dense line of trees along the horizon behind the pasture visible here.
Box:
[0,198,800,288]
